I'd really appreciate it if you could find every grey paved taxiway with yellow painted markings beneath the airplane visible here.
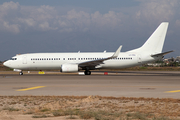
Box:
[0,71,180,98]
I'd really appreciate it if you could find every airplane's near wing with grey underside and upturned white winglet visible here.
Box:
[78,45,122,68]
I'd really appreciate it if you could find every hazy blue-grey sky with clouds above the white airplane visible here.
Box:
[0,0,180,61]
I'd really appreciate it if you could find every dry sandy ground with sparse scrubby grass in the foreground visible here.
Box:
[0,96,180,120]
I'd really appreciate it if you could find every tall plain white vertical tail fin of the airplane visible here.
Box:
[129,22,169,53]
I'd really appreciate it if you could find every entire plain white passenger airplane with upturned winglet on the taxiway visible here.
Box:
[3,22,173,75]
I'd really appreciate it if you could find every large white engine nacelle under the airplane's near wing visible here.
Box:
[61,63,78,72]
